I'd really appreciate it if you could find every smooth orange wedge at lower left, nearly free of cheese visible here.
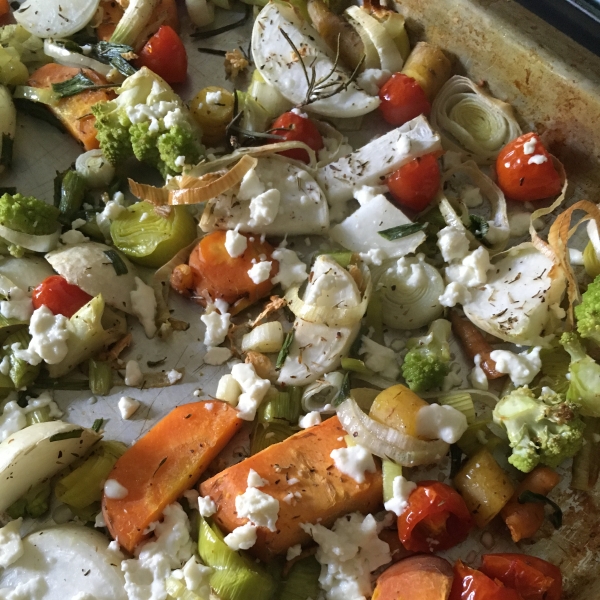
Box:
[102,402,243,552]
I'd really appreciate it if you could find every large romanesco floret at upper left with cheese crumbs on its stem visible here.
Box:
[92,67,203,178]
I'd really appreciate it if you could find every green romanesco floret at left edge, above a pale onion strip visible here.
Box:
[0,194,59,235]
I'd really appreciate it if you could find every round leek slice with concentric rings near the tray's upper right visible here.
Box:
[431,75,521,164]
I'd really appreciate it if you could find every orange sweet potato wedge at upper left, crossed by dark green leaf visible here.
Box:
[27,63,115,150]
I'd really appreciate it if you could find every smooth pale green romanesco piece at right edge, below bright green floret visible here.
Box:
[560,332,600,417]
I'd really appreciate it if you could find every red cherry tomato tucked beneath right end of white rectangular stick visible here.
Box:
[385,154,440,212]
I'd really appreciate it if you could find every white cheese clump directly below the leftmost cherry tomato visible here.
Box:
[14,305,69,365]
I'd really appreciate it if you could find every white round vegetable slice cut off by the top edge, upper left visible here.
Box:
[13,0,100,38]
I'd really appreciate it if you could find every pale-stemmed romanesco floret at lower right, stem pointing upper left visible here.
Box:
[494,387,585,473]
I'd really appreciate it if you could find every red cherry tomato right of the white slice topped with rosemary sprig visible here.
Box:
[379,73,431,126]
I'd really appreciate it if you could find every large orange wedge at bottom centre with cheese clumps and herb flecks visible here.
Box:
[200,417,383,561]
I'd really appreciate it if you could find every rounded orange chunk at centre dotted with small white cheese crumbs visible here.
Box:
[171,231,279,314]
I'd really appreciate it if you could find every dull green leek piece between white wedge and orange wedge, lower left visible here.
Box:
[54,442,127,509]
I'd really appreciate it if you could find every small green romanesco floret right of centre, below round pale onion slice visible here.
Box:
[402,319,451,392]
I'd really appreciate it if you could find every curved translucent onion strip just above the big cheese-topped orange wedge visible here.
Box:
[337,398,450,467]
